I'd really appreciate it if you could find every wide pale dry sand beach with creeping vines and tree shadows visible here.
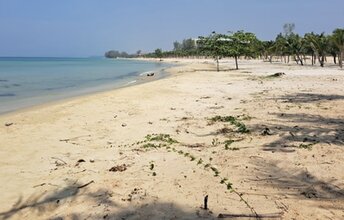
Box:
[0,60,344,219]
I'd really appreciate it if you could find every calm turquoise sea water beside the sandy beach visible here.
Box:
[0,58,170,113]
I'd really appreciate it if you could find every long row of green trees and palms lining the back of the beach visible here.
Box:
[144,24,344,71]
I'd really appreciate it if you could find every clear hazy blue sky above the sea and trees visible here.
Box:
[0,0,344,57]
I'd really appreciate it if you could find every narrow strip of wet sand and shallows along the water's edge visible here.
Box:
[0,60,177,118]
